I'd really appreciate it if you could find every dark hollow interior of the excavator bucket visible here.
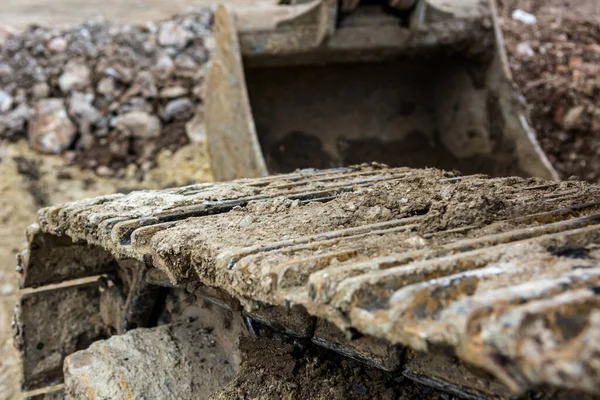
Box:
[245,56,525,176]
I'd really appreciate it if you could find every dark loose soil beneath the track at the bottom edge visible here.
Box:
[211,337,450,400]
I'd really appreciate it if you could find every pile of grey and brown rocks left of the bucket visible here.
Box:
[0,9,214,176]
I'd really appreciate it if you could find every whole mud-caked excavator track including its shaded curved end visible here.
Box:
[15,164,600,398]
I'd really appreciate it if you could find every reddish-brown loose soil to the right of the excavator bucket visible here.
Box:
[500,0,600,182]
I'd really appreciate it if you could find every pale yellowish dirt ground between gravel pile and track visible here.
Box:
[0,142,212,399]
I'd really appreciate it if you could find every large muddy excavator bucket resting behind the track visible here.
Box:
[205,0,557,180]
